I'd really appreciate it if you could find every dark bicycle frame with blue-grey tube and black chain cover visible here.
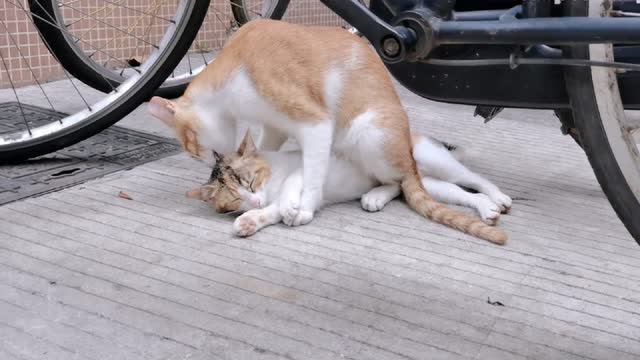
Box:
[321,0,640,109]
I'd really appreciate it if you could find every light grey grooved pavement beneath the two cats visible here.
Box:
[0,85,640,360]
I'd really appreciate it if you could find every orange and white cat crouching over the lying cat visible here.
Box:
[149,20,511,243]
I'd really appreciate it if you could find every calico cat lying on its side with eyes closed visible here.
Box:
[187,132,511,244]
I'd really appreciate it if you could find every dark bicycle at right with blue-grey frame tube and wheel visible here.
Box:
[321,0,640,244]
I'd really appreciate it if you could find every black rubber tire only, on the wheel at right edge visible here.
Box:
[565,1,640,245]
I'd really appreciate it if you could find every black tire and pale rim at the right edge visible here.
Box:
[565,0,640,245]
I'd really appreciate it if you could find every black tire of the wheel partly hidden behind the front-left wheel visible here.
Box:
[29,0,289,99]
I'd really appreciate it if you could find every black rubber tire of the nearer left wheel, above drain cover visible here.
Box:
[0,0,210,163]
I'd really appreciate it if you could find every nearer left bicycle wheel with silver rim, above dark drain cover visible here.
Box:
[0,0,209,162]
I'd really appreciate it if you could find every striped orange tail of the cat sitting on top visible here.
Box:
[401,171,507,245]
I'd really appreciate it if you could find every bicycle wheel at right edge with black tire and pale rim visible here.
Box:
[565,0,640,244]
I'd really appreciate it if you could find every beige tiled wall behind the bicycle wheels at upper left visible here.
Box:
[0,0,343,88]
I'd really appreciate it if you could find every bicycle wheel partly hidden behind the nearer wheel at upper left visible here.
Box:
[29,0,289,98]
